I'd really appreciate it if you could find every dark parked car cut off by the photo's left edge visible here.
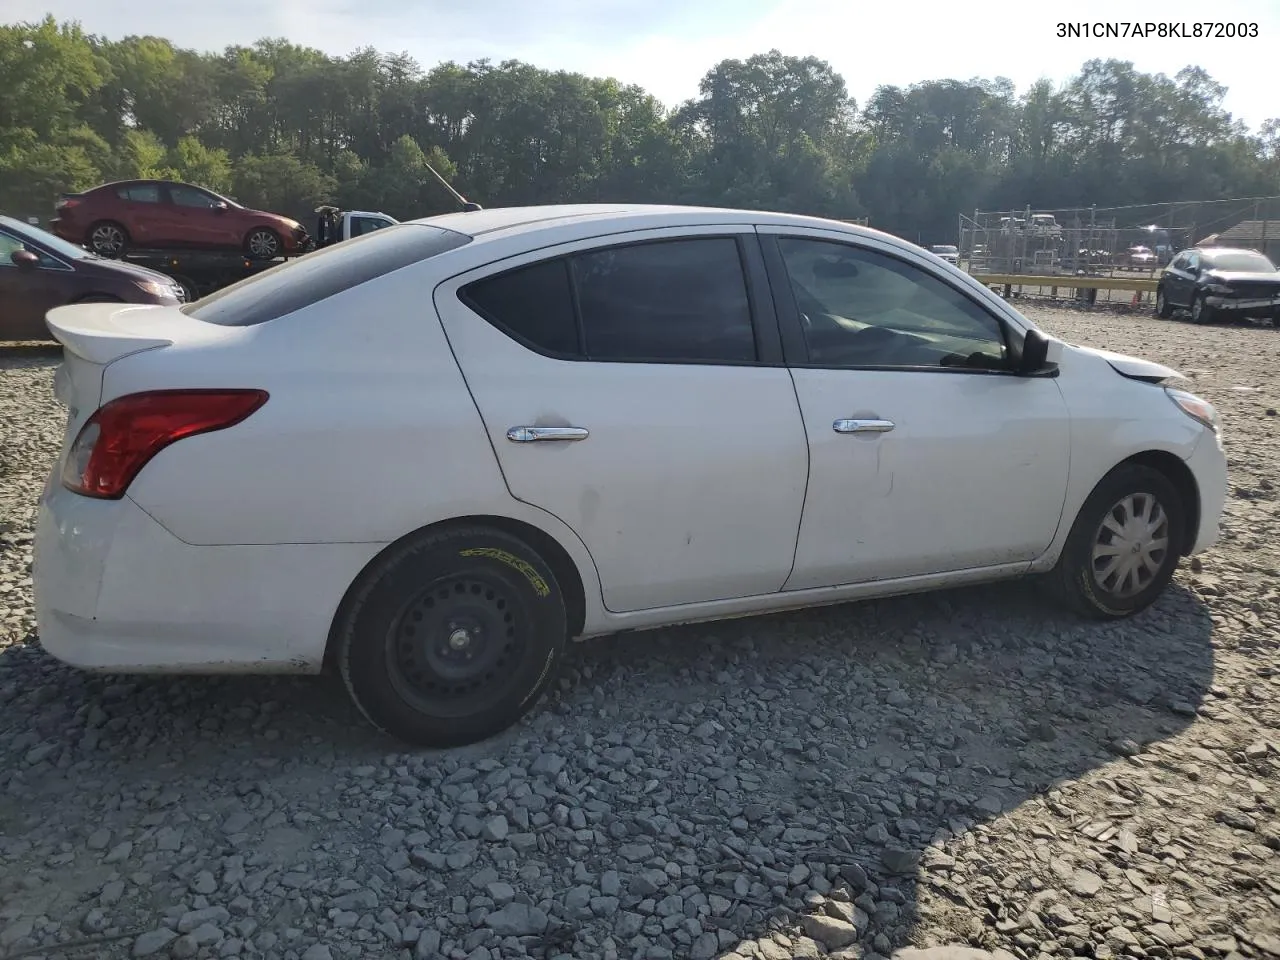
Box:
[0,216,183,340]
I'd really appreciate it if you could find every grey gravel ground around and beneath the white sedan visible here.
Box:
[0,307,1280,960]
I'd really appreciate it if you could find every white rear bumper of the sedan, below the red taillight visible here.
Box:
[32,484,378,673]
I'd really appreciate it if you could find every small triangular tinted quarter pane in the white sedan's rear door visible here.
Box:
[462,260,581,356]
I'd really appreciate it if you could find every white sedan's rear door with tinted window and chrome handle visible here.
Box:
[435,227,808,612]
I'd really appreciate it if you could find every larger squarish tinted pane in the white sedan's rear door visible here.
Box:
[572,237,756,364]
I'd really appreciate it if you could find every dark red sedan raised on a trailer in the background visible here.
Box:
[50,180,310,260]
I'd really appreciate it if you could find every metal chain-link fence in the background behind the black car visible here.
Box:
[959,197,1280,276]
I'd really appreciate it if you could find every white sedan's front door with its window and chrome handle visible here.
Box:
[762,228,1070,590]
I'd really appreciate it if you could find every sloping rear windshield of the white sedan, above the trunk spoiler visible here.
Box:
[180,224,471,326]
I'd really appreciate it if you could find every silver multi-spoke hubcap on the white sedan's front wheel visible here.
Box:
[1093,493,1169,598]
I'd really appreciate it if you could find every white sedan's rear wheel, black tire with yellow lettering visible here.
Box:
[334,527,568,748]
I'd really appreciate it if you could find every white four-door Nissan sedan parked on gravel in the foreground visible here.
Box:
[35,205,1226,745]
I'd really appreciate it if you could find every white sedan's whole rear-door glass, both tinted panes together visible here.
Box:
[461,237,756,364]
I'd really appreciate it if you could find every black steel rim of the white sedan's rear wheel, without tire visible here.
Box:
[387,572,522,716]
